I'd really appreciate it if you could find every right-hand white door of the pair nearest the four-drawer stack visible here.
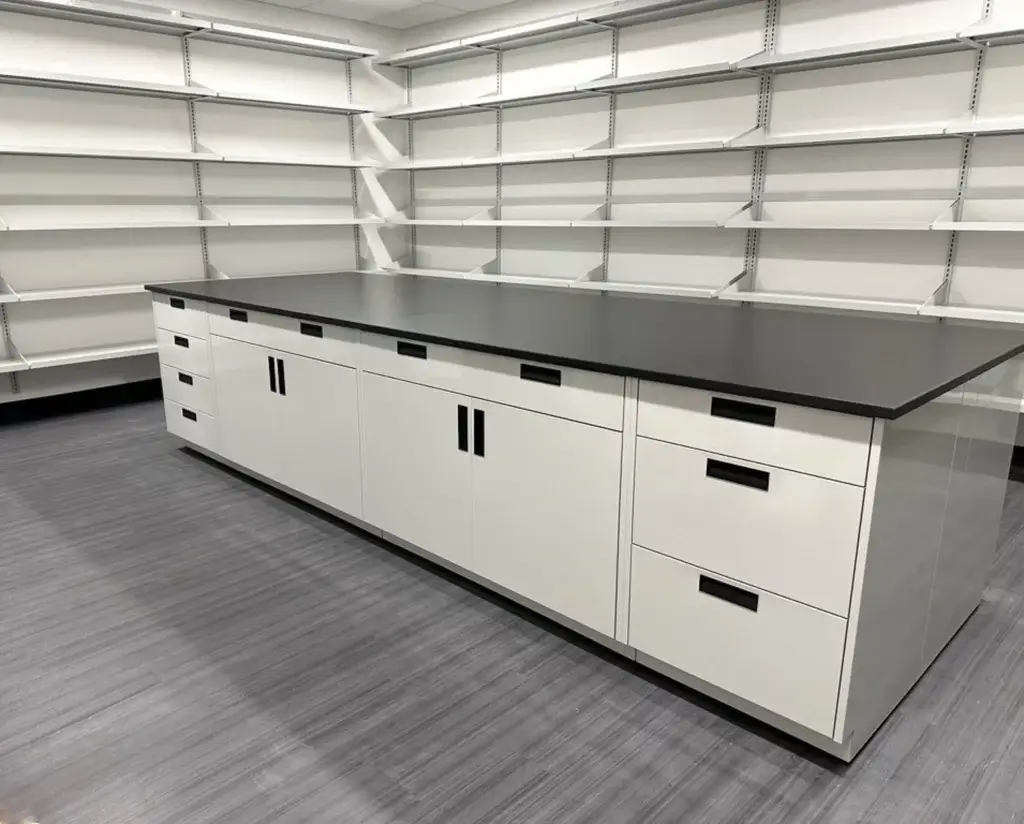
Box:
[276,350,362,518]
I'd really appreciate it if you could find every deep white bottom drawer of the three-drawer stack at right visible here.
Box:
[629,547,846,738]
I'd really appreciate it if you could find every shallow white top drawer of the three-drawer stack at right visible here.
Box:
[637,381,872,486]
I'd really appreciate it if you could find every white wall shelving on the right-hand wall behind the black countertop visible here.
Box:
[366,0,1024,343]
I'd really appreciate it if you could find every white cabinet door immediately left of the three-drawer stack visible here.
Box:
[473,401,622,636]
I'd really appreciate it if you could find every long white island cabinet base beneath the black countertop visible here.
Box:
[154,294,1018,760]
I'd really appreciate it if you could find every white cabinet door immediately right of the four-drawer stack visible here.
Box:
[210,335,286,480]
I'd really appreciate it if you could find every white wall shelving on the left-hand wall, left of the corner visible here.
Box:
[0,0,386,402]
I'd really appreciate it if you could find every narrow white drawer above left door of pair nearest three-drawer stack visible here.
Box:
[361,332,471,395]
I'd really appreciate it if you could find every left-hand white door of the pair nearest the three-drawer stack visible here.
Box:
[362,373,474,569]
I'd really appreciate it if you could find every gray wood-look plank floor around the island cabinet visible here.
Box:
[0,403,1024,824]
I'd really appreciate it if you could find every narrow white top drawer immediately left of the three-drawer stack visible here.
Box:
[466,352,626,432]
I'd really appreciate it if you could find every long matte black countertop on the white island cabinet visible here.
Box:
[146,272,1024,419]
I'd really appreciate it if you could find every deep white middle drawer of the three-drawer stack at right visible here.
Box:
[633,438,864,615]
